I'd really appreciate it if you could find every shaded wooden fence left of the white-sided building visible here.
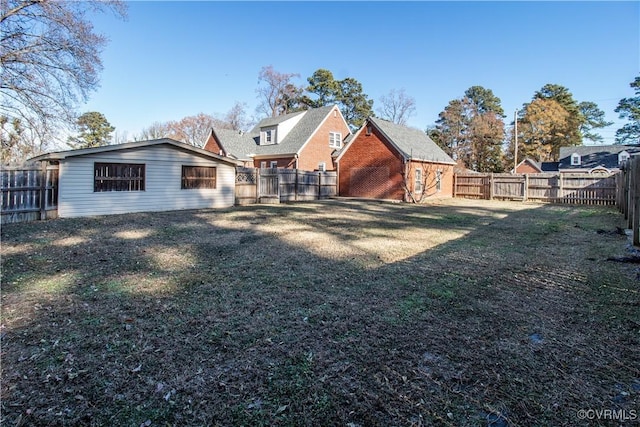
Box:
[0,166,58,224]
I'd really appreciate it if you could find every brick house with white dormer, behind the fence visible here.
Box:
[204,105,351,171]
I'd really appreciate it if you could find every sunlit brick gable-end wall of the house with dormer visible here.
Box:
[298,107,350,171]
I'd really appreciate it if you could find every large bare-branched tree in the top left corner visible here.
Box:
[0,0,126,159]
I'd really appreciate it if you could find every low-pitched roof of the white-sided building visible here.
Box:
[29,138,240,166]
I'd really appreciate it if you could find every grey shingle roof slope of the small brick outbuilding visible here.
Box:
[369,117,455,164]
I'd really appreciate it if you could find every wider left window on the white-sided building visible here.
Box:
[93,163,145,193]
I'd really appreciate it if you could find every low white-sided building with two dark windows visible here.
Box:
[31,138,239,218]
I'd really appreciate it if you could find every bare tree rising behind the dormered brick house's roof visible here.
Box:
[256,65,303,117]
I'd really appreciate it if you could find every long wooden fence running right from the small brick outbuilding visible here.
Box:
[453,173,616,205]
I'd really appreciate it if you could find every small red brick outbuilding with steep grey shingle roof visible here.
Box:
[336,117,456,201]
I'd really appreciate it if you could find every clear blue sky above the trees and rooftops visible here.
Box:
[82,1,640,143]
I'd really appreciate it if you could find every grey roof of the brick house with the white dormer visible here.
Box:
[213,105,348,160]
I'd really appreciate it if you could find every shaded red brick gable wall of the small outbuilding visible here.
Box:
[338,127,405,200]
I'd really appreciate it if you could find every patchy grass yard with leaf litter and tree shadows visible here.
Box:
[0,199,640,427]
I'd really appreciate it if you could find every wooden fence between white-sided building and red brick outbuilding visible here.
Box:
[236,167,338,205]
